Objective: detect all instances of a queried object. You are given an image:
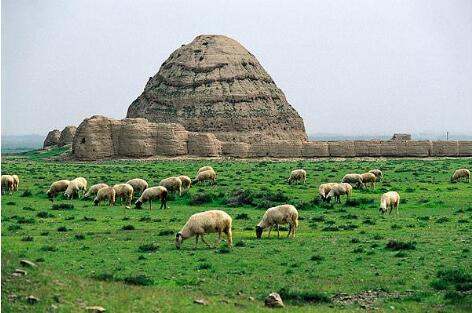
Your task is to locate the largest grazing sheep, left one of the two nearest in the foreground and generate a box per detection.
[175,210,233,249]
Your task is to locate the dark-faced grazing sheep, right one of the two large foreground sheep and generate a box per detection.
[256,204,298,239]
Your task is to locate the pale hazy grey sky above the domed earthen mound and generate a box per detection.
[1,0,472,135]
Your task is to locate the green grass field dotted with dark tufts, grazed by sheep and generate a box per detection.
[1,151,472,312]
